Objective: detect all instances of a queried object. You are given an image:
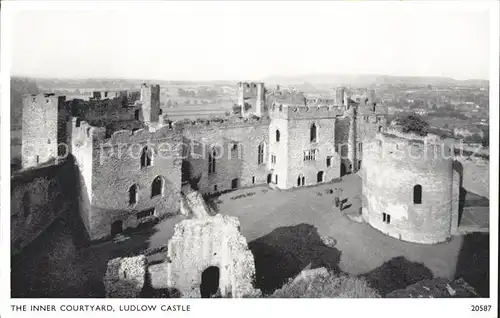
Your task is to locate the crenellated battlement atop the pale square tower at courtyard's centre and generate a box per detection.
[269,102,346,119]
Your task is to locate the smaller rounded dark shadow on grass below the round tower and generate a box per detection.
[361,256,433,297]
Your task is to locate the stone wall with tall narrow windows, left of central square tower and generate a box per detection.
[184,119,269,193]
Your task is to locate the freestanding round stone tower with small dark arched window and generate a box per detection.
[361,133,458,243]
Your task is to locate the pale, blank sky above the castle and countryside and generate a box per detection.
[6,1,492,80]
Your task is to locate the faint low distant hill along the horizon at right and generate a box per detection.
[265,74,489,86]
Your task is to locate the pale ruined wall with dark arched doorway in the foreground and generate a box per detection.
[166,214,255,298]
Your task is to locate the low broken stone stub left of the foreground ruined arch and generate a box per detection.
[103,255,147,298]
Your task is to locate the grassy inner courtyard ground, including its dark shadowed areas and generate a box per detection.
[12,175,489,297]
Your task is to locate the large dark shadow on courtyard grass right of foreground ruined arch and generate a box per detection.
[248,223,340,294]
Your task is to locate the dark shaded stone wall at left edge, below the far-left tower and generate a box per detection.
[10,162,73,254]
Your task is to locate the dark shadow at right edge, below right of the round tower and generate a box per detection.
[455,233,490,297]
